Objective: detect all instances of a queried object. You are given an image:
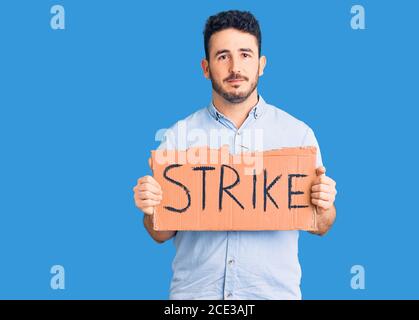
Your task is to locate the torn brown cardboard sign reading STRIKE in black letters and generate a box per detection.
[151,146,317,231]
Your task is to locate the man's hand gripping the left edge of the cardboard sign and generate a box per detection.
[133,176,163,215]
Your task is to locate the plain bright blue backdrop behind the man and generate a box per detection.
[0,0,419,299]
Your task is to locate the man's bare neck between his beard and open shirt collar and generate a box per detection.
[212,89,258,128]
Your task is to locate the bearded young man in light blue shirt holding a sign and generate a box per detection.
[134,11,336,299]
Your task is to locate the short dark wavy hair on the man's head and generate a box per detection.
[204,10,262,61]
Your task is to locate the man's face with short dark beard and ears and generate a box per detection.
[202,29,265,103]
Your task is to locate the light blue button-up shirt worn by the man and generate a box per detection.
[159,96,322,299]
